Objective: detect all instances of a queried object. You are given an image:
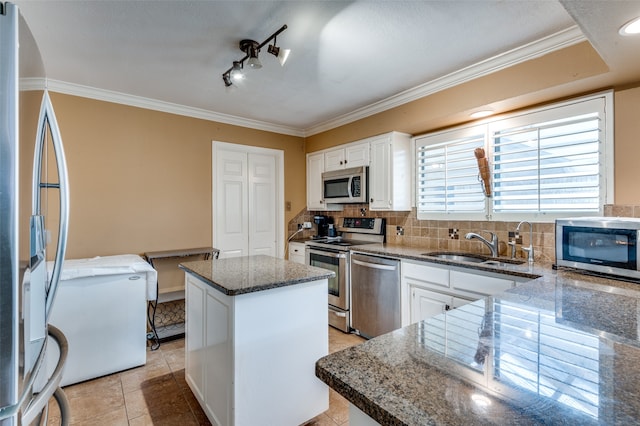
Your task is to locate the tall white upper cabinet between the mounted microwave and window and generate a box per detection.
[368,132,411,211]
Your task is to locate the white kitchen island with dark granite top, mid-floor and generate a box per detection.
[180,256,334,426]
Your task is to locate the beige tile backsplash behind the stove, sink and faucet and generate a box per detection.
[288,204,640,262]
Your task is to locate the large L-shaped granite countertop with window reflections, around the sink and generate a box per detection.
[316,245,640,425]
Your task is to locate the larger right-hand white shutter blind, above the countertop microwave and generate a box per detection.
[490,99,604,214]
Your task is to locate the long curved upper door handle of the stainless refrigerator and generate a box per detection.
[32,90,69,321]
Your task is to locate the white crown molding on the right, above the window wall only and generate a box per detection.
[304,25,587,136]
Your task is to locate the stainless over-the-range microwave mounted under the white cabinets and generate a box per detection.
[322,167,369,204]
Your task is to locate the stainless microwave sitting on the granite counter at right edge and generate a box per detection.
[556,217,640,279]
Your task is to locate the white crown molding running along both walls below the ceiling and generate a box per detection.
[20,26,586,137]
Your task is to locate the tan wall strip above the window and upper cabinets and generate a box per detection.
[306,42,609,152]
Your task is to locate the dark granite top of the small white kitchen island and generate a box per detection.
[179,255,335,296]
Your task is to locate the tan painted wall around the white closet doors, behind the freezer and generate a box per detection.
[21,93,306,258]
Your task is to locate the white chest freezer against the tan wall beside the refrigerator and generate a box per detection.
[47,255,157,386]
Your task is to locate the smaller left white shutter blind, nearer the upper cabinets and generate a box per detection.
[416,127,486,217]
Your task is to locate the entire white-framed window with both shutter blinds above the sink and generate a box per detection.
[415,92,613,221]
